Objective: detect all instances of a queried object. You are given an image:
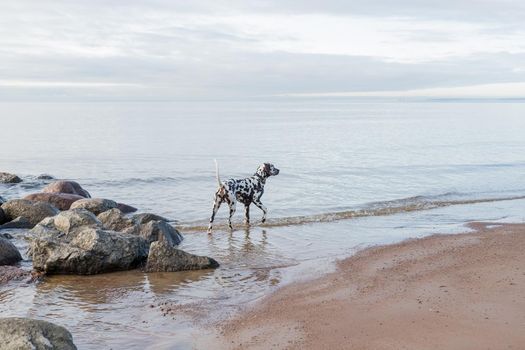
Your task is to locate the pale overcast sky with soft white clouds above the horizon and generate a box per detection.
[0,0,525,100]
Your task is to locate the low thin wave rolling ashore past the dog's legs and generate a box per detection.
[180,192,525,231]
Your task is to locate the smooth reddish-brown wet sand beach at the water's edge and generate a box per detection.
[214,223,525,350]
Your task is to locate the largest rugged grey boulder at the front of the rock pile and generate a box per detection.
[30,227,148,275]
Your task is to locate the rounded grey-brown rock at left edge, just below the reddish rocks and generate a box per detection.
[2,199,59,227]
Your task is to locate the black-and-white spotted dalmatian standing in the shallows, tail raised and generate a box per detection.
[208,161,279,233]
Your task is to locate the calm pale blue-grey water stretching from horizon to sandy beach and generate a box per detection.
[0,100,525,349]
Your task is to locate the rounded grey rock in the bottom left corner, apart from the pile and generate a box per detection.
[0,317,77,350]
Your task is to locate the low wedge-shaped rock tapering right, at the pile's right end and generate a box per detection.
[146,242,219,272]
